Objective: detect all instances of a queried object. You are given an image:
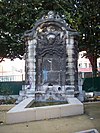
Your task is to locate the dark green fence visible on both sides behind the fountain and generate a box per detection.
[0,77,100,95]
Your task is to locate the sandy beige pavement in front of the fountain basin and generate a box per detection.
[0,102,100,133]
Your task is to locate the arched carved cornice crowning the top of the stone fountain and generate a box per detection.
[24,11,79,39]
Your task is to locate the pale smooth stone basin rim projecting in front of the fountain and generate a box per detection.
[6,98,84,124]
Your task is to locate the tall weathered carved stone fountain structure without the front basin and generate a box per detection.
[21,11,78,101]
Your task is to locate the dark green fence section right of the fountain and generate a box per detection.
[83,77,100,92]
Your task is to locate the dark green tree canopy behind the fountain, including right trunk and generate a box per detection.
[0,0,100,76]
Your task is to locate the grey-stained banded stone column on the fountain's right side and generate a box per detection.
[66,35,76,95]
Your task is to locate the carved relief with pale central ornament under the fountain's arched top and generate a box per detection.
[37,22,65,48]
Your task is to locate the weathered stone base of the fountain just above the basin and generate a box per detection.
[17,84,80,103]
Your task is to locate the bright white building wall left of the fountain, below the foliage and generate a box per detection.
[0,59,25,82]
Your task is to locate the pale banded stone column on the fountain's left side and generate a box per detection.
[26,39,37,92]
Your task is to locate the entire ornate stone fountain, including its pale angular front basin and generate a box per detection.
[6,11,84,124]
